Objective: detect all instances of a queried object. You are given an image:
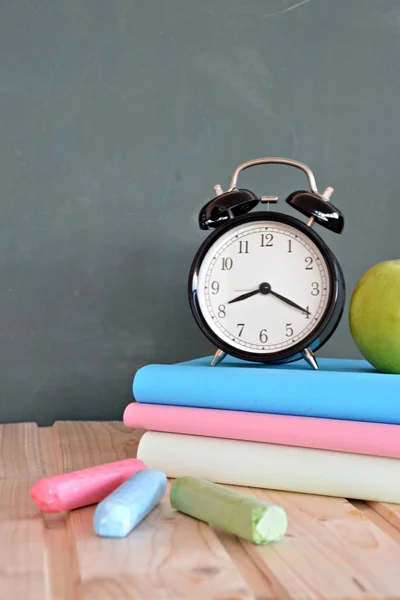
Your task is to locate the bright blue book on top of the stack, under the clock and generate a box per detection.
[133,356,400,424]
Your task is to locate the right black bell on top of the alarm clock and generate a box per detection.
[286,189,344,233]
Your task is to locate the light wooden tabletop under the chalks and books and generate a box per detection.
[0,422,400,600]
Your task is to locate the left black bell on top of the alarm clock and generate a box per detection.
[199,186,260,229]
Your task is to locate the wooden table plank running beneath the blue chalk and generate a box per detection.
[54,422,253,600]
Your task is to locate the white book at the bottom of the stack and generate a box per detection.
[137,431,400,504]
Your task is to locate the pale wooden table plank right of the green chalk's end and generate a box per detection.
[231,488,400,600]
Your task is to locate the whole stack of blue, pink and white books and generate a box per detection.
[123,356,400,503]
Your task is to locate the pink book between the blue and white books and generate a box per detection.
[123,402,400,458]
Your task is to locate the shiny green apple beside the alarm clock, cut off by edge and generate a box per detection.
[349,259,400,374]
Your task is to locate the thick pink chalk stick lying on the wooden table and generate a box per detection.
[29,458,147,513]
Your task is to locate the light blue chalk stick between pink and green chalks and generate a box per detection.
[93,469,167,538]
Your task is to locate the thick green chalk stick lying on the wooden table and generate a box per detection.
[170,476,288,544]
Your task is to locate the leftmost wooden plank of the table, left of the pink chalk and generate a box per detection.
[0,423,49,600]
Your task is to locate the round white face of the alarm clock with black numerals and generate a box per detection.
[195,220,330,354]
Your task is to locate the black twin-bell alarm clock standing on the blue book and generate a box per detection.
[189,157,346,369]
